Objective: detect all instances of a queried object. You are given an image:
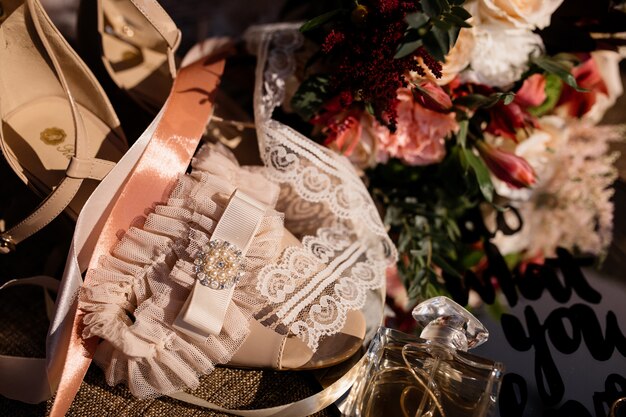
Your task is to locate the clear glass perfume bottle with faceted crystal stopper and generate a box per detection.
[344,297,504,417]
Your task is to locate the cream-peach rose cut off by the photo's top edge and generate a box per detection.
[477,0,563,30]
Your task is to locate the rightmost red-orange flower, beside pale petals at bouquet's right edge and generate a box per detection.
[558,58,609,118]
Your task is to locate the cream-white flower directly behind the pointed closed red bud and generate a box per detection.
[490,116,569,201]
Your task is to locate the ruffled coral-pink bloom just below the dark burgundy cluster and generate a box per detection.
[377,88,459,165]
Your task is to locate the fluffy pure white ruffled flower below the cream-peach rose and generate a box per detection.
[461,25,543,87]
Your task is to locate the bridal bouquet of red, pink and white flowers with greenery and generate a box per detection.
[285,0,626,306]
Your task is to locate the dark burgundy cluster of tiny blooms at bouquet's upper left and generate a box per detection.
[322,0,441,132]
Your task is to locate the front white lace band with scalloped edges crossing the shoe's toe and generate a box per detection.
[257,221,388,350]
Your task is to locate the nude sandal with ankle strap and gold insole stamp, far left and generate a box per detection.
[0,0,128,253]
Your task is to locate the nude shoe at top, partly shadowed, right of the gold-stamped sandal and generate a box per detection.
[95,0,181,114]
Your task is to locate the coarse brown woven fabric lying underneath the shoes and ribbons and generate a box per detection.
[0,268,339,417]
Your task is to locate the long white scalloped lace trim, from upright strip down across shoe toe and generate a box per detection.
[246,24,396,350]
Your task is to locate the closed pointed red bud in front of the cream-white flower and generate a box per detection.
[476,141,536,188]
